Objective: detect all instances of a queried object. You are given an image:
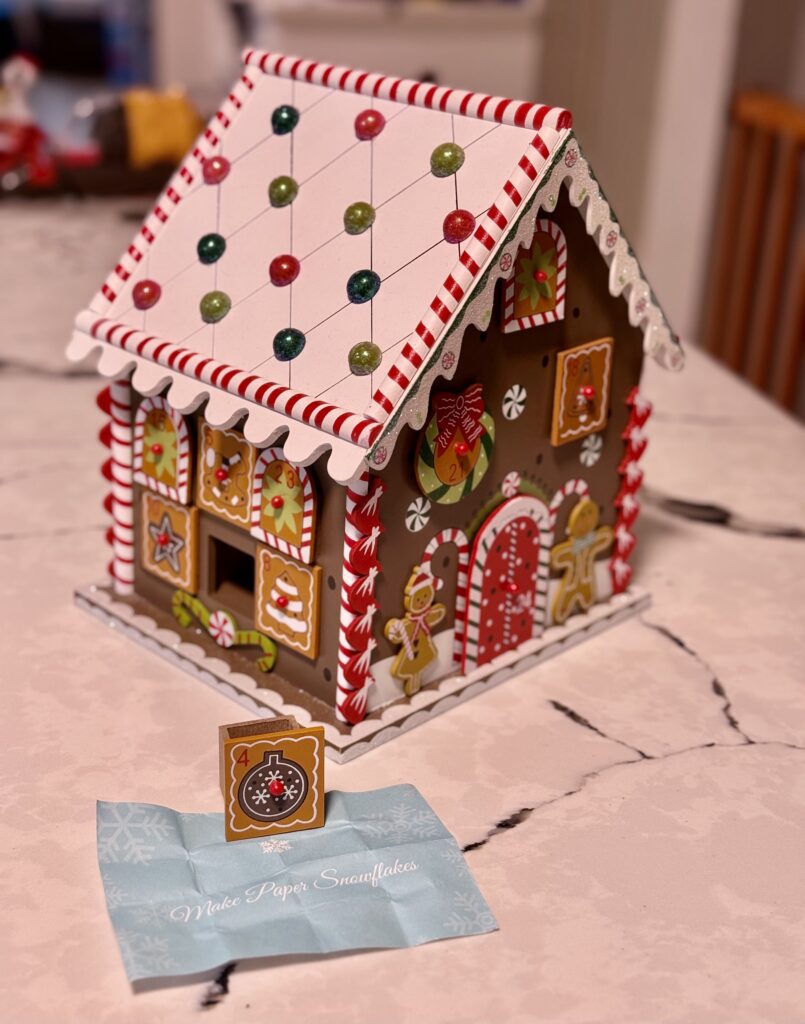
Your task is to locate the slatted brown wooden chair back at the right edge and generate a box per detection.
[702,91,805,409]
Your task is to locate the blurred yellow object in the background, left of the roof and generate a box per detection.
[123,89,202,170]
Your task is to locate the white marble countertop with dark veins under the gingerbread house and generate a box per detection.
[0,201,805,1024]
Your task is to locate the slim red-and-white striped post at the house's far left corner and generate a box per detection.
[109,379,134,595]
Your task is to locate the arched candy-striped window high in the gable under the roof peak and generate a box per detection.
[503,217,567,334]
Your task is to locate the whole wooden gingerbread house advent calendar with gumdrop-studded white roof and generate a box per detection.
[70,50,682,760]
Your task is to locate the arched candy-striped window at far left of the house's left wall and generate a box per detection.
[134,397,190,505]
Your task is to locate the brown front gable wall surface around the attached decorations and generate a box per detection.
[376,190,643,658]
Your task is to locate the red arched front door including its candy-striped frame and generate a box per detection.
[462,495,552,673]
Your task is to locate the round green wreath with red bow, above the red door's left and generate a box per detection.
[416,384,495,505]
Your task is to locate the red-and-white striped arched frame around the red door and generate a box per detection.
[462,495,554,673]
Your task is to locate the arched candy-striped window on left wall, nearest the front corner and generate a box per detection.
[251,447,316,564]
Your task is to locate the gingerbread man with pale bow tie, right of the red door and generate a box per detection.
[551,498,612,624]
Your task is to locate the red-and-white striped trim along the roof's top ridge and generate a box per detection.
[243,49,573,130]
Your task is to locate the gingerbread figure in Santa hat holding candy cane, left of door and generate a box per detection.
[383,565,446,696]
